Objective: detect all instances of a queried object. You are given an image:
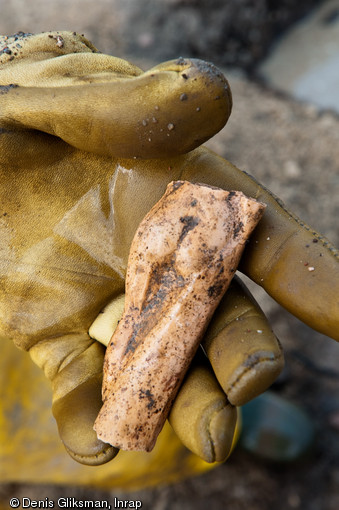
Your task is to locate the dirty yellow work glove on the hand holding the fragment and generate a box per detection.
[0,32,339,465]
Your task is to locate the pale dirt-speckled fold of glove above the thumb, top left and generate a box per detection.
[0,31,142,82]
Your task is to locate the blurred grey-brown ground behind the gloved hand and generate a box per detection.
[0,0,339,510]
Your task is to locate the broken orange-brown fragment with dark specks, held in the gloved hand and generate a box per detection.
[94,181,265,451]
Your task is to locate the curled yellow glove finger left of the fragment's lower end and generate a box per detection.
[30,334,118,465]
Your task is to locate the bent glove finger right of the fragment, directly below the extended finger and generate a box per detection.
[202,277,284,406]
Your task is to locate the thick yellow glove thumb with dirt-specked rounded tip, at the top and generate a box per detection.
[0,32,232,158]
